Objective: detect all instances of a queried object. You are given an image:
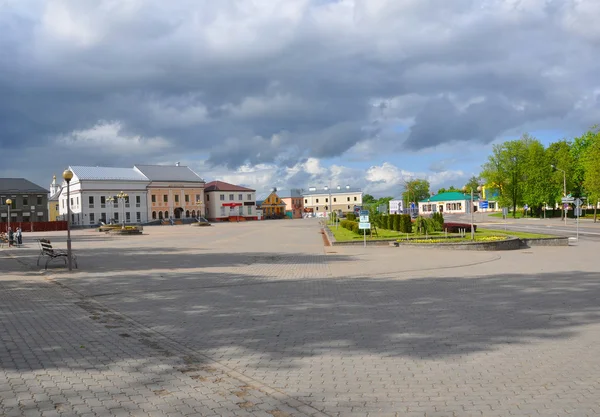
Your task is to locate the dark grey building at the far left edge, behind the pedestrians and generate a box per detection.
[0,178,48,223]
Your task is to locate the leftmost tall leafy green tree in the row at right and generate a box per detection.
[481,135,530,217]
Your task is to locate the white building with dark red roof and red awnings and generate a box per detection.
[204,181,257,221]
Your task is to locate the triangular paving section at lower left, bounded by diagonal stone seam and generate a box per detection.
[0,251,319,417]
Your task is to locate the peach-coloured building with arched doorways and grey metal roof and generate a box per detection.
[134,164,206,220]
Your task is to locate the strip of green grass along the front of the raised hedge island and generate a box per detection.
[329,226,554,242]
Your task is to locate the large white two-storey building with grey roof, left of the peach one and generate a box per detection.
[58,166,150,226]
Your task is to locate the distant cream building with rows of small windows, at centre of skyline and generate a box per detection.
[302,186,363,217]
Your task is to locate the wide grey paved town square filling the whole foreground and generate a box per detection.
[0,220,600,416]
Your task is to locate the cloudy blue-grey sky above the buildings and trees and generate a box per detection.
[0,0,600,196]
